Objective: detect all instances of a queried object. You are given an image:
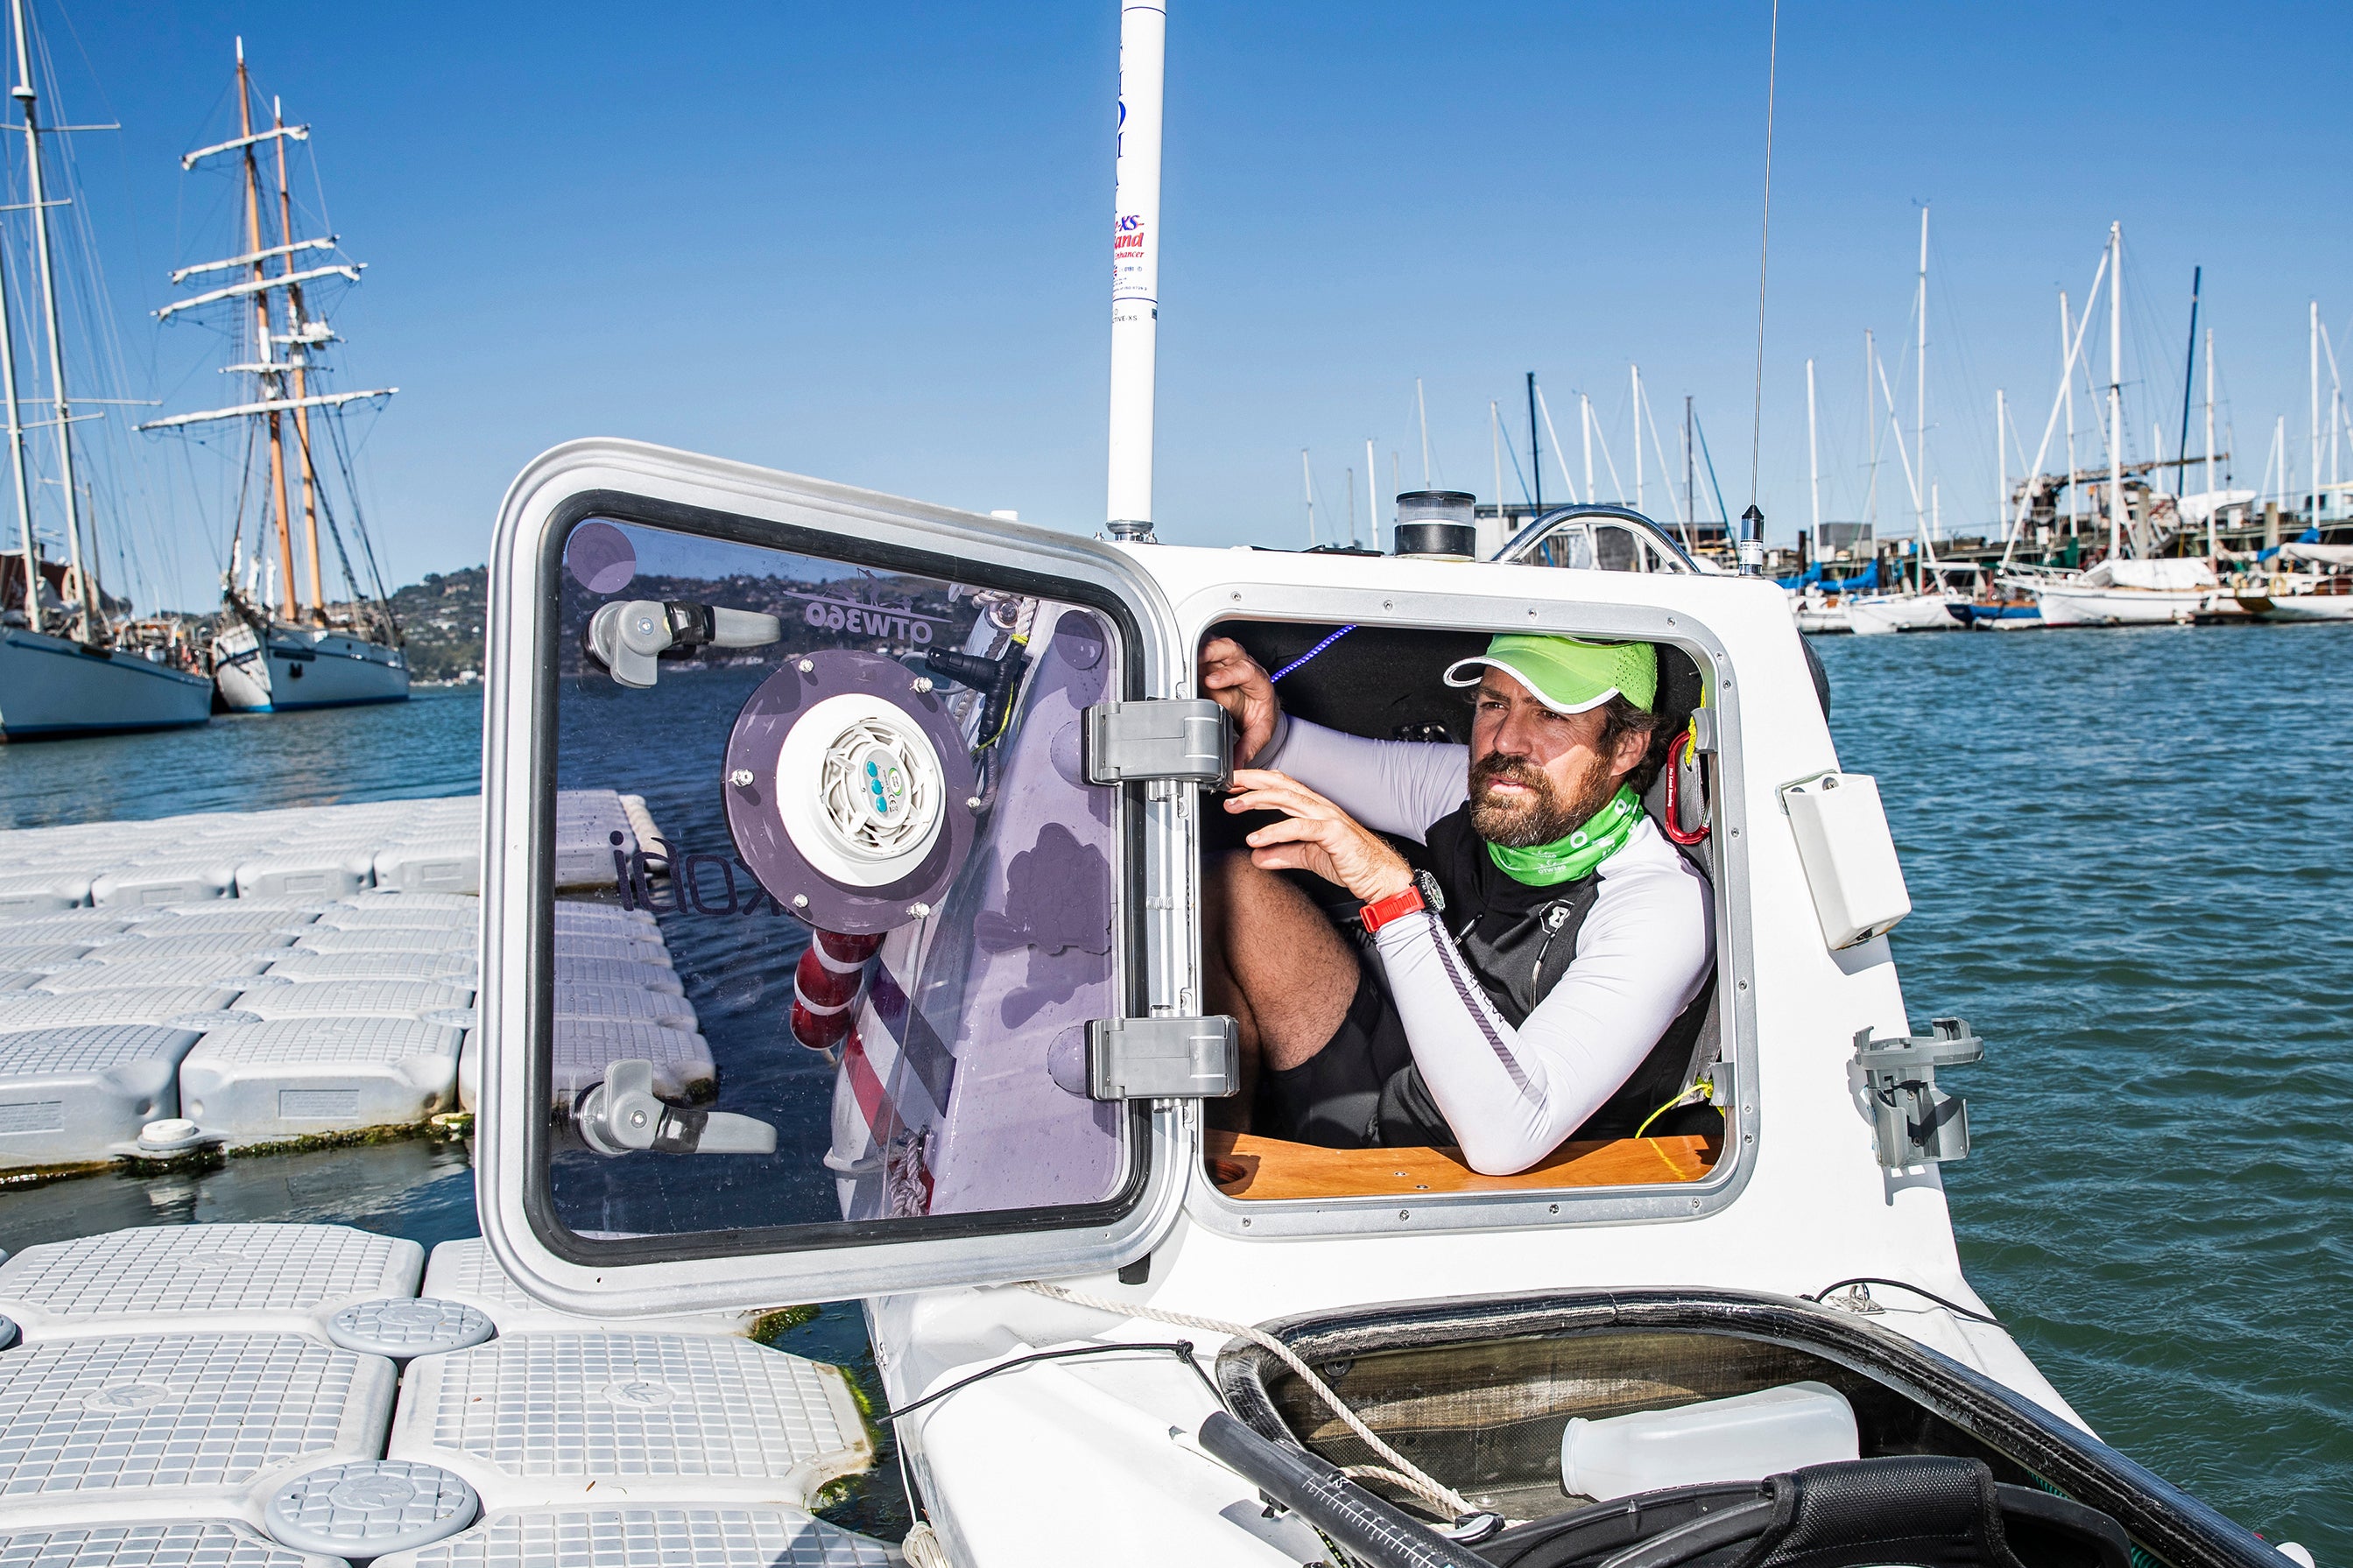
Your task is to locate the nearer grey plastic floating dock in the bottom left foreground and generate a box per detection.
[0,1225,897,1568]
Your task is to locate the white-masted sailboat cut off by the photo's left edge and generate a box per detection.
[0,0,212,741]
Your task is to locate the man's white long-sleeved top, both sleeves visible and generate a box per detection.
[1250,714,1713,1176]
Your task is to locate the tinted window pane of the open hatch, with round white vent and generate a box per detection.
[548,519,1127,1236]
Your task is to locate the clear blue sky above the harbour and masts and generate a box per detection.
[11,0,2353,604]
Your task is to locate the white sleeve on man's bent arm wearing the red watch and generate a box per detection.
[1374,823,1710,1176]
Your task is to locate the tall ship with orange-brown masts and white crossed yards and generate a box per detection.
[139,38,410,713]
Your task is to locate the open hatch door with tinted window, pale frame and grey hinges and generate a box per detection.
[476,442,1233,1314]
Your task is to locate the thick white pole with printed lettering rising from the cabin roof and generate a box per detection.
[1110,0,1167,538]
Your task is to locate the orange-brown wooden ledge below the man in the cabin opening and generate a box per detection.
[1207,1131,1722,1201]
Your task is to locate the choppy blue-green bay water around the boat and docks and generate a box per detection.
[0,628,2353,1565]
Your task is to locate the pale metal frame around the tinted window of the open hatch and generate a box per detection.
[476,439,1195,1314]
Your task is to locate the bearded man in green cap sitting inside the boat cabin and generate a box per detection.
[1200,635,1713,1176]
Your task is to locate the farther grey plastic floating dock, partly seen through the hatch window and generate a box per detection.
[0,790,687,1171]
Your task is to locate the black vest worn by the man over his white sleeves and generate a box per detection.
[1424,802,1715,1138]
